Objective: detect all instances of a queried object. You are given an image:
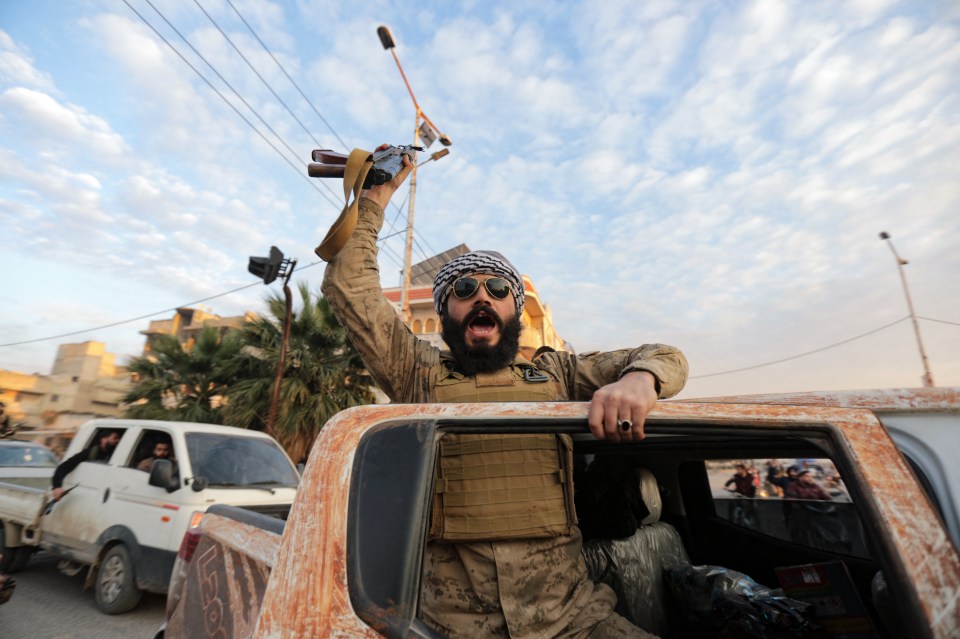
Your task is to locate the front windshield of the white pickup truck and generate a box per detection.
[186,433,298,488]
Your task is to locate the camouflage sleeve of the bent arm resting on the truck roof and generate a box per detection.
[537,344,688,401]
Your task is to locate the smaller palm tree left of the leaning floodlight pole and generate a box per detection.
[123,327,242,424]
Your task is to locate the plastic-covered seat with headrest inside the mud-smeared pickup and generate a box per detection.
[583,468,690,637]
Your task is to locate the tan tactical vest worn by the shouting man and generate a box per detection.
[429,361,577,542]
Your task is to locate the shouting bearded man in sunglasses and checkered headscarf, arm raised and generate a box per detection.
[318,147,687,639]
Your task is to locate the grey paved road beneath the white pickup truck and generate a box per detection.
[0,553,166,639]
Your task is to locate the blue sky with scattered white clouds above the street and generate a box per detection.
[0,0,960,397]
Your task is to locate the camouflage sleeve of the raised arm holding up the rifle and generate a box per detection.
[321,198,439,402]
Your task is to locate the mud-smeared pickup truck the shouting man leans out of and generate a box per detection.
[158,389,960,638]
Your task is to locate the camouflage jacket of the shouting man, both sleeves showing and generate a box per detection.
[322,198,687,403]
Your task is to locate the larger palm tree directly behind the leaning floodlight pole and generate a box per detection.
[223,283,373,460]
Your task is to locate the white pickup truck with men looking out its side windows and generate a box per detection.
[0,419,300,614]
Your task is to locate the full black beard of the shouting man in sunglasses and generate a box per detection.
[440,306,523,376]
